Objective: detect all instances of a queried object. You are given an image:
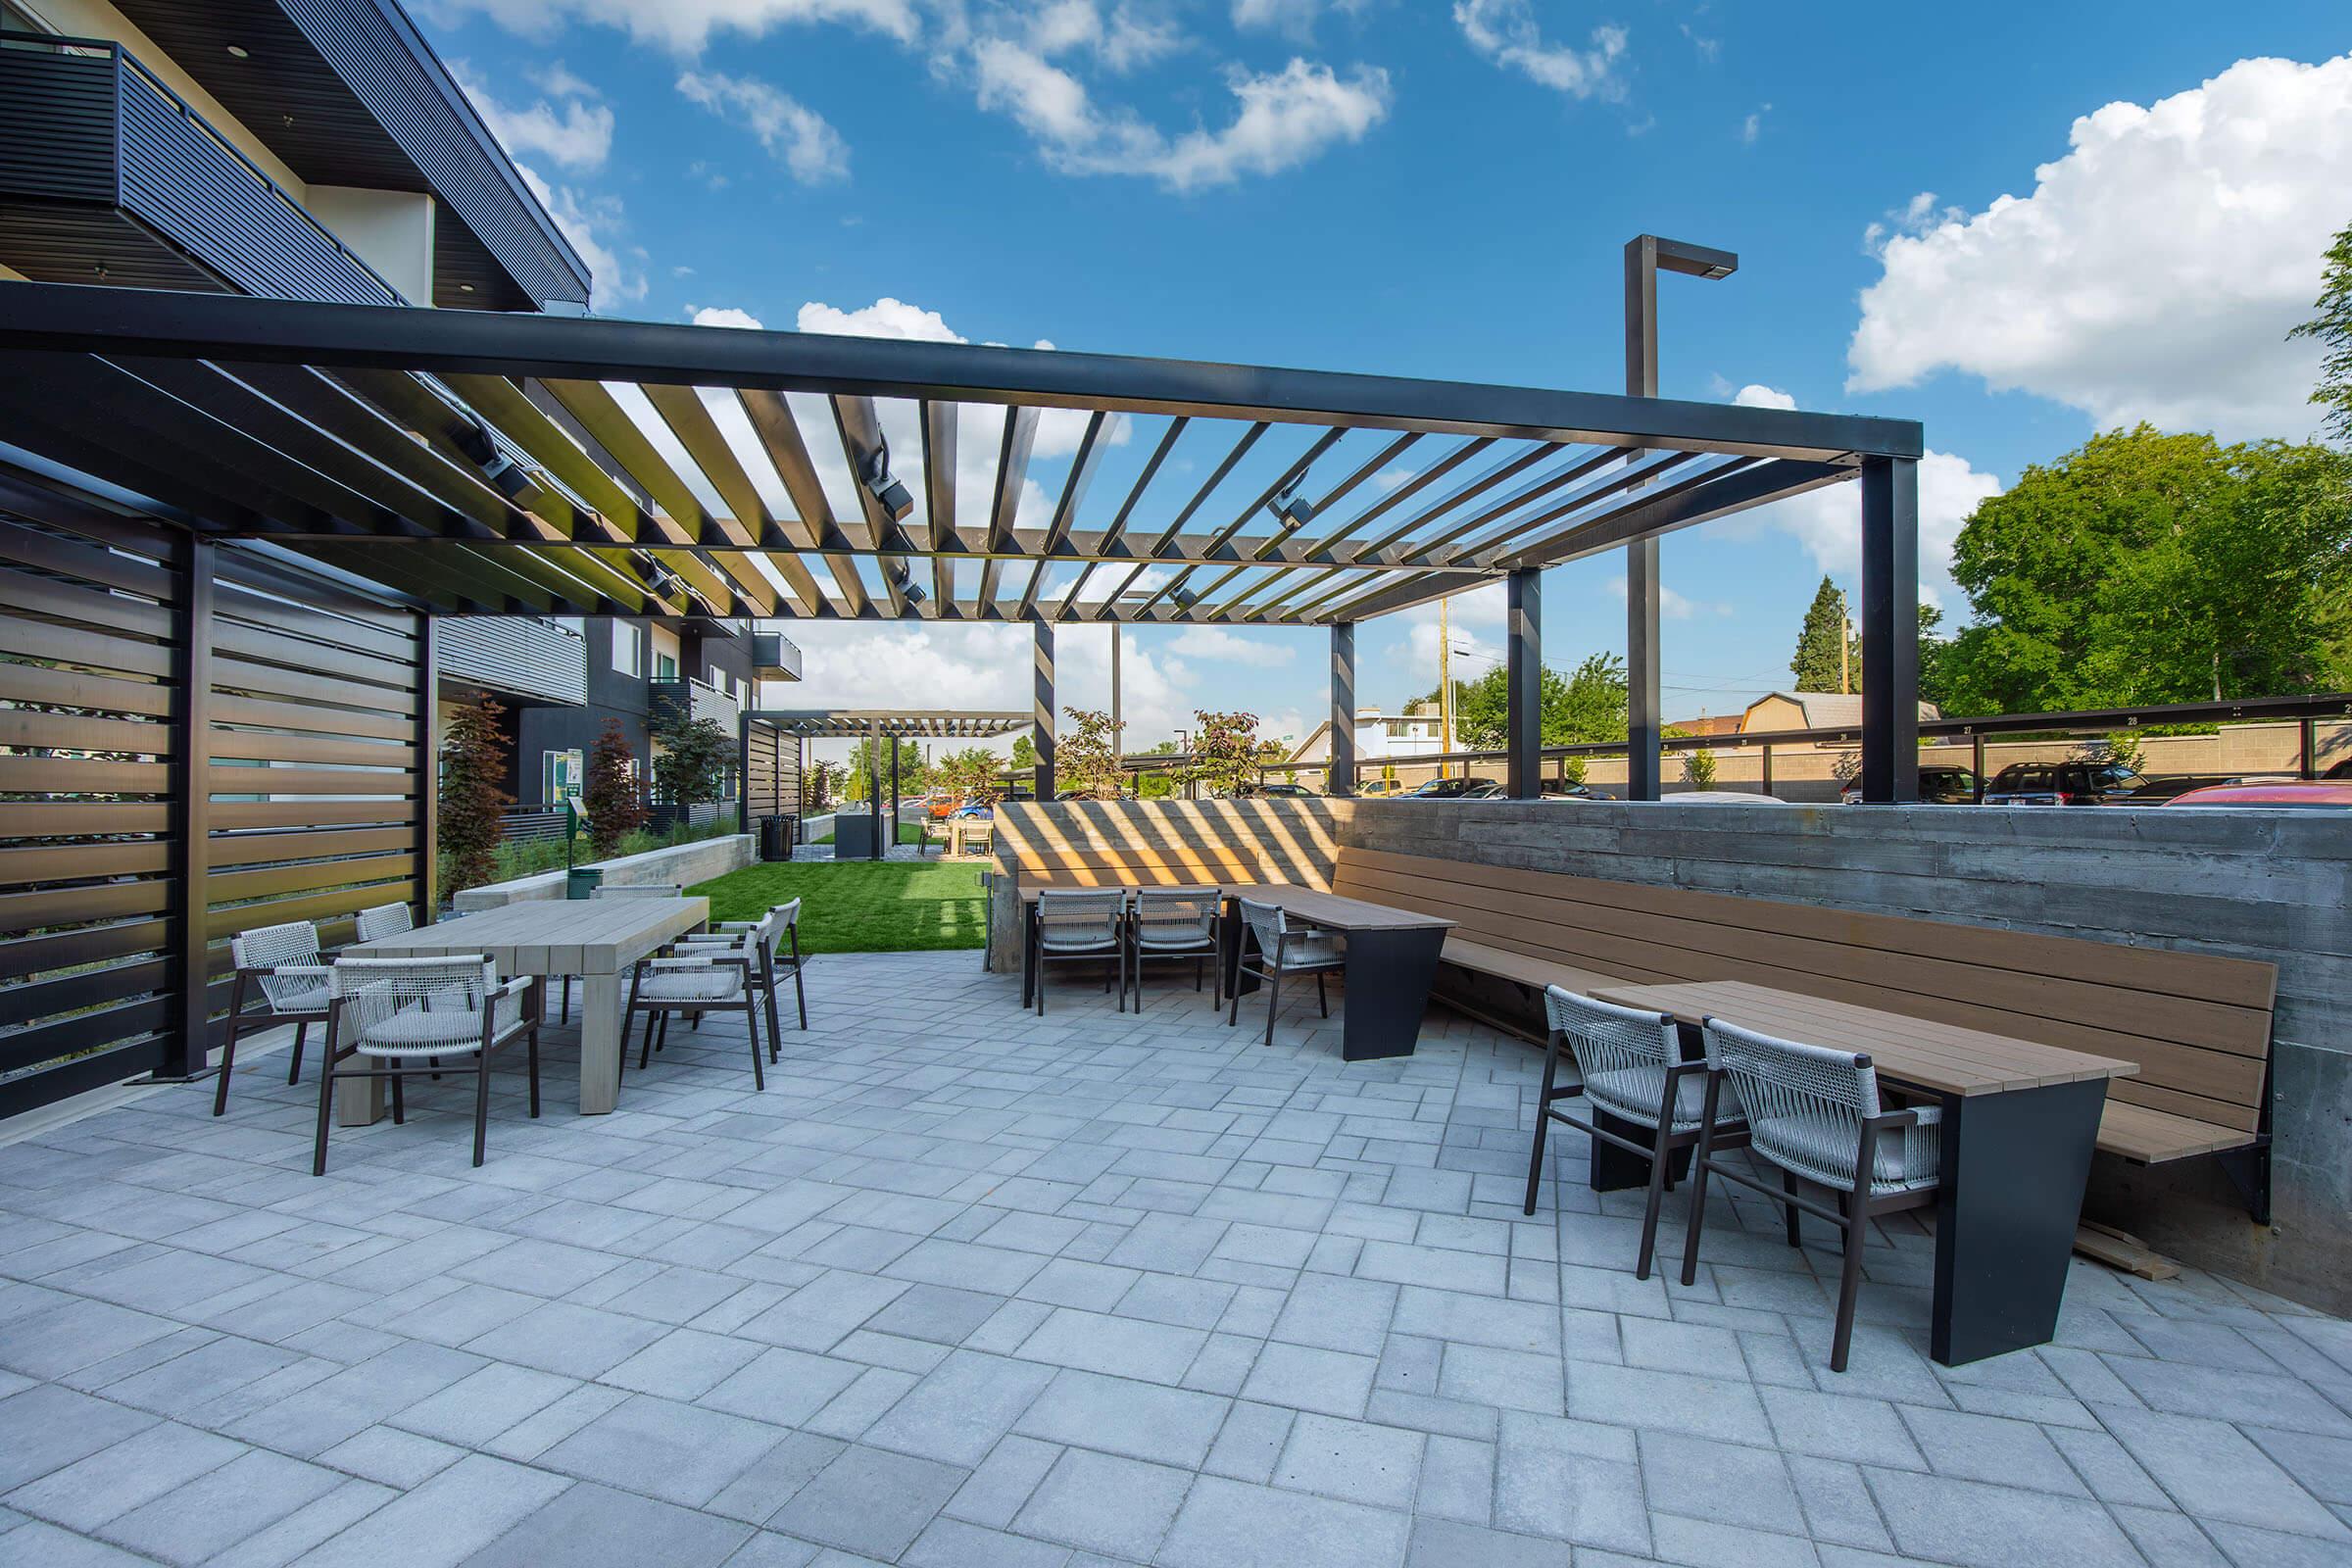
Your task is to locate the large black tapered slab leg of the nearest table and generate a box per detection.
[1929,1079,2107,1366]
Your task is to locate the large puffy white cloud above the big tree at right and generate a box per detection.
[1846,54,2352,437]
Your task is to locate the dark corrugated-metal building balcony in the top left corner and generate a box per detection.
[0,35,407,306]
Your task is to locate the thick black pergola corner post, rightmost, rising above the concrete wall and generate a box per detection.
[1863,459,1919,804]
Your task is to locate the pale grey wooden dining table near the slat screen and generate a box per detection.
[336,898,710,1126]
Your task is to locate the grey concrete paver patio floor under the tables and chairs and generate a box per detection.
[0,953,2352,1568]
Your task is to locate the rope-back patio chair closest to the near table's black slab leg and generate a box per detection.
[1682,1018,1942,1373]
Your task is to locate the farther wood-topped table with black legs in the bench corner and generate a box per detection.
[1021,882,1453,1062]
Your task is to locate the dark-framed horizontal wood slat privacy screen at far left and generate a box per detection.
[0,491,433,1114]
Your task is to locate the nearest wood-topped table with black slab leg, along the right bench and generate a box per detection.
[1592,980,2138,1366]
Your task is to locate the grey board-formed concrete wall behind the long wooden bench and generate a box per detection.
[998,800,2352,1312]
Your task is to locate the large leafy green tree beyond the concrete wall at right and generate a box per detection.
[1938,425,2352,712]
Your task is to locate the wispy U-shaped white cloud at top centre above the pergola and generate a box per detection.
[971,37,1390,190]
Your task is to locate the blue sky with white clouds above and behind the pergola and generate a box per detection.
[416,0,2352,743]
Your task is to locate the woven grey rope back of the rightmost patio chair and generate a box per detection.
[1705,1018,1905,1185]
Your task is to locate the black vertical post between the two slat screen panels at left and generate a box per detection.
[155,536,216,1079]
